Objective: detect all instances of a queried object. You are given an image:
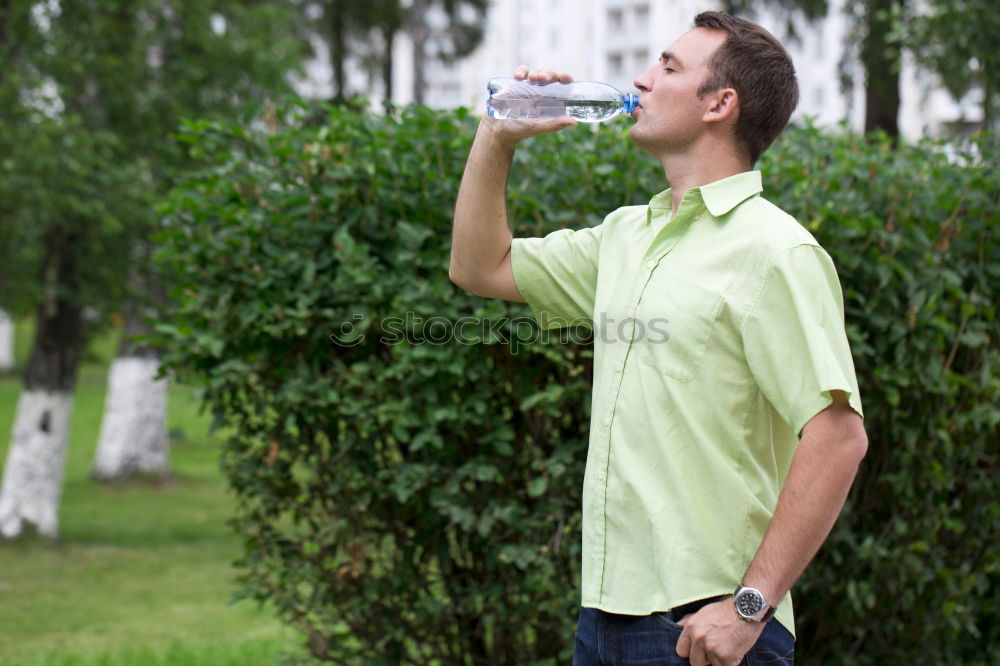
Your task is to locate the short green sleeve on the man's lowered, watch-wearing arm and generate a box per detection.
[743,244,863,435]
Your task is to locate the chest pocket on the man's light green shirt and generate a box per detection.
[637,271,725,382]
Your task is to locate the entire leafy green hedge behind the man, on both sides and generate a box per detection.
[152,104,1000,664]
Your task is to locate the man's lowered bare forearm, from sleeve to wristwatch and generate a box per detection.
[743,396,867,604]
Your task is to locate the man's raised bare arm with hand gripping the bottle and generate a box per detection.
[448,65,576,302]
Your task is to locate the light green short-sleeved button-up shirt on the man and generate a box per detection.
[511,171,861,632]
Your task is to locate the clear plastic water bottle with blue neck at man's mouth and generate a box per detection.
[486,77,639,123]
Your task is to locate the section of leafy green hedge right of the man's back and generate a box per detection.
[764,126,1000,665]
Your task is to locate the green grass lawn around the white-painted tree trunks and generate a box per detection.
[0,323,300,666]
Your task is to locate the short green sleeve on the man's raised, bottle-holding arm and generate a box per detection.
[510,225,604,330]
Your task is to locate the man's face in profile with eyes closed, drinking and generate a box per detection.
[629,28,727,157]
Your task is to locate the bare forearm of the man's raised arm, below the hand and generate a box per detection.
[448,120,514,286]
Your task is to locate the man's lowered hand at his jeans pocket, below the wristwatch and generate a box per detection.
[677,599,764,666]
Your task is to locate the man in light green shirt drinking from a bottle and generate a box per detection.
[449,12,867,666]
